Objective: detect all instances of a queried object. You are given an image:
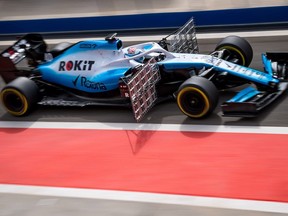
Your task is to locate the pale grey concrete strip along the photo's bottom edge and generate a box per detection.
[0,194,287,216]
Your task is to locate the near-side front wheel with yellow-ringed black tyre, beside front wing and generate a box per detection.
[177,76,219,119]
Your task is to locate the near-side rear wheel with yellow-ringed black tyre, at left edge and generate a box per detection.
[0,77,39,116]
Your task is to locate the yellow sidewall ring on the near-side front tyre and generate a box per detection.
[177,86,210,118]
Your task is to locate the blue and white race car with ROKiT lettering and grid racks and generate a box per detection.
[0,19,288,121]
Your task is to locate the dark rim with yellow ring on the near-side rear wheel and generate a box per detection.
[1,88,28,116]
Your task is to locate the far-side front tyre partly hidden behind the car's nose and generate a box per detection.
[215,35,253,67]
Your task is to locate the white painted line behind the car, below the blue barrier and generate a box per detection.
[0,30,288,46]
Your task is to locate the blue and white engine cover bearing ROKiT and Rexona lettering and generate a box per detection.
[37,40,130,93]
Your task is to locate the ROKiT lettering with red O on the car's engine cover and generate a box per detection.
[58,60,95,71]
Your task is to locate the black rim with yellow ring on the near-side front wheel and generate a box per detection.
[177,87,210,118]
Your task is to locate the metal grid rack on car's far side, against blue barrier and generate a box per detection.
[158,18,199,54]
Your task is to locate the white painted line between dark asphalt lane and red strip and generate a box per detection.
[0,121,288,134]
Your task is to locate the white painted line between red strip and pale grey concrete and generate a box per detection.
[0,184,288,214]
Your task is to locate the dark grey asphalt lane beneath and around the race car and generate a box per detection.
[0,35,288,127]
